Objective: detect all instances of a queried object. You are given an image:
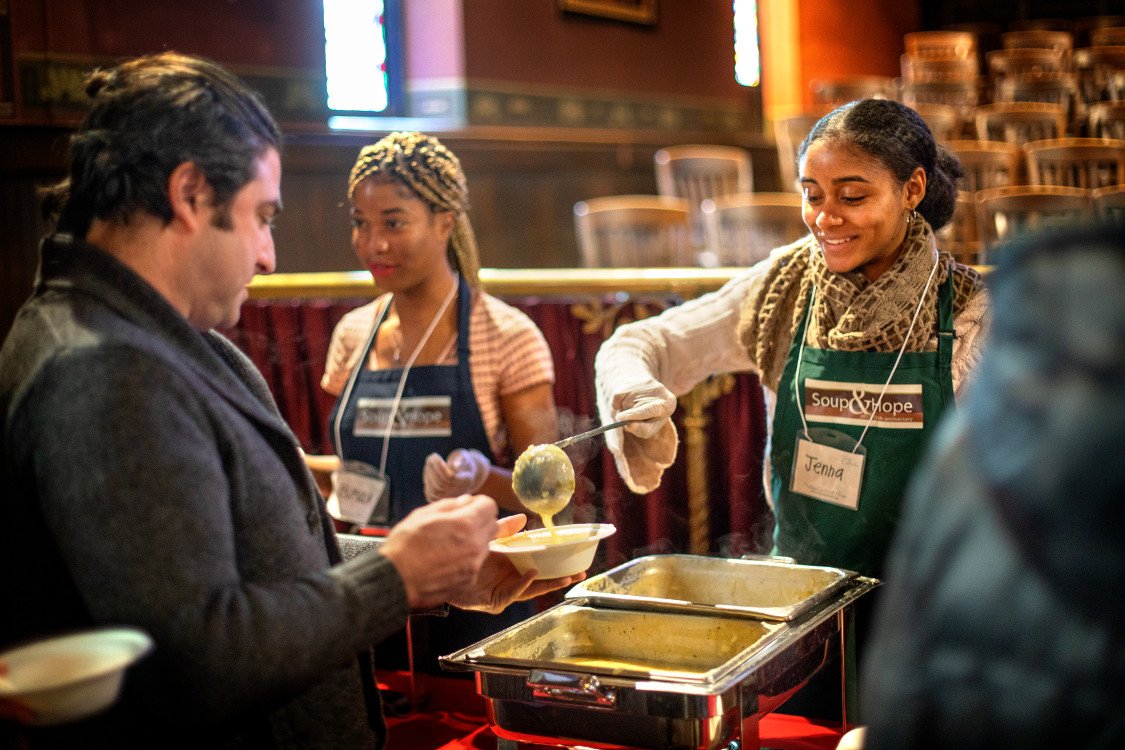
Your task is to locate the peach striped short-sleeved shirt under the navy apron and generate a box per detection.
[321,292,555,461]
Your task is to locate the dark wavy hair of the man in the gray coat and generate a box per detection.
[43,52,281,237]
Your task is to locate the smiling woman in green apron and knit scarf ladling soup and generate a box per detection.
[596,99,988,717]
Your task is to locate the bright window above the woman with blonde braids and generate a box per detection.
[324,0,403,116]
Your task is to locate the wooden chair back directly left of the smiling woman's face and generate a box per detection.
[702,192,809,265]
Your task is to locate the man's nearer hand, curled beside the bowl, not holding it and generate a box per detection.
[380,495,500,609]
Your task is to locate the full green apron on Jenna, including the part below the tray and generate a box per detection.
[770,277,954,722]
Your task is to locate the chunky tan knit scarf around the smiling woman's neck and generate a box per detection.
[738,213,984,391]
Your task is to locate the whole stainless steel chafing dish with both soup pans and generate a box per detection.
[441,555,879,750]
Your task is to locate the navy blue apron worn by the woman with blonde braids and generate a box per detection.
[329,279,533,674]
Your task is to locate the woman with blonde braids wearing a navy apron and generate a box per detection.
[312,133,557,666]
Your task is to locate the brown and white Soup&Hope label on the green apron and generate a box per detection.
[804,378,926,430]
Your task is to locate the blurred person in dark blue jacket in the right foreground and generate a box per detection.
[863,224,1125,750]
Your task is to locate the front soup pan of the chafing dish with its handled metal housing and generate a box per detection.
[440,561,879,750]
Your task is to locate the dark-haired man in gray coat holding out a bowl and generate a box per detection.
[0,53,577,748]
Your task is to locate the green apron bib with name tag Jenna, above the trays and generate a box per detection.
[770,275,953,578]
